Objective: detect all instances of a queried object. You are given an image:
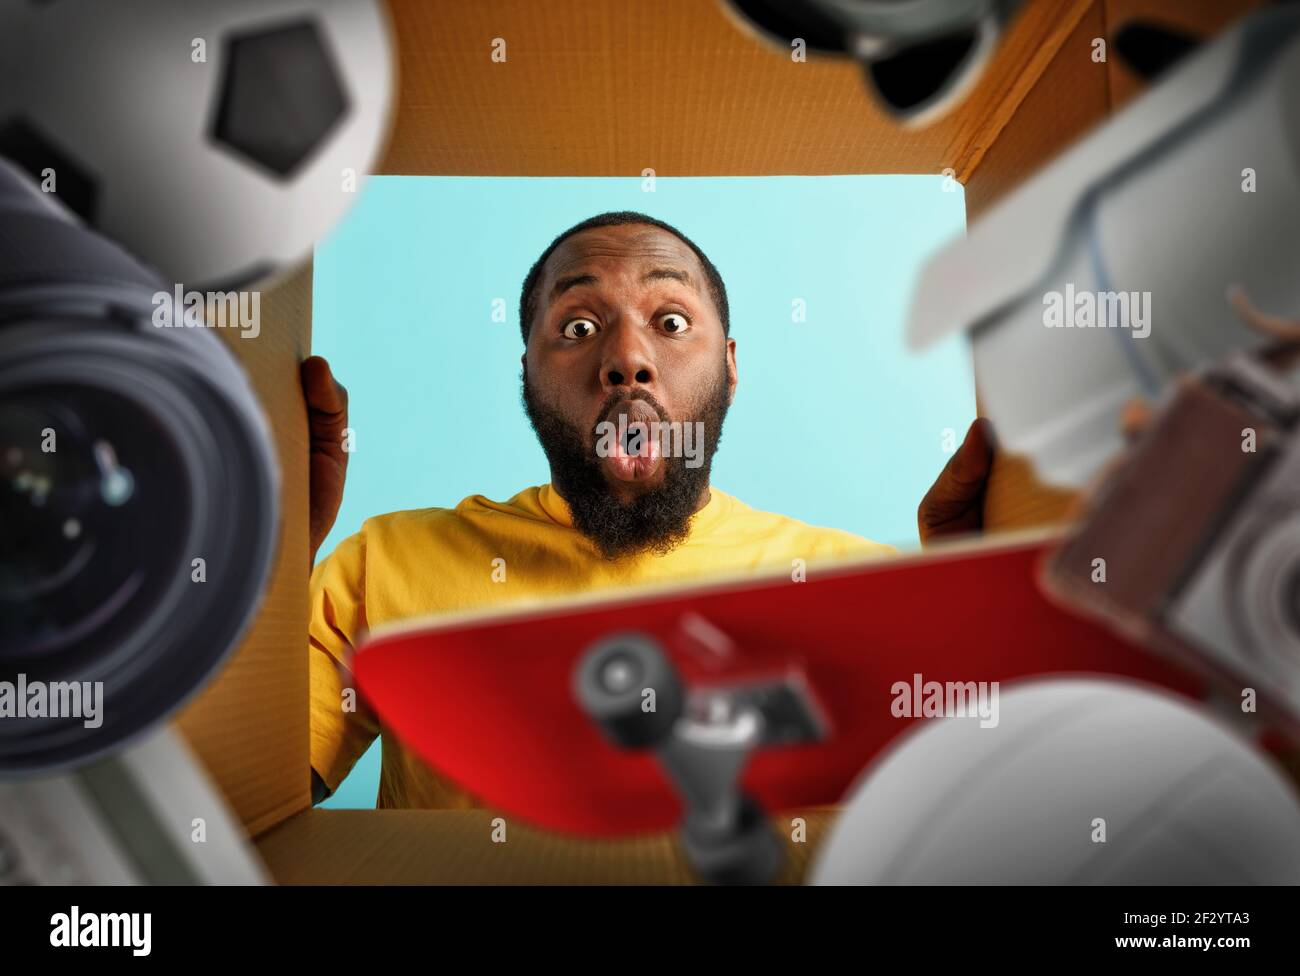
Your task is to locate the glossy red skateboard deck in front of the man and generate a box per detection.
[355,530,1204,836]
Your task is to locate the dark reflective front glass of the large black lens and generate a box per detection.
[0,386,190,671]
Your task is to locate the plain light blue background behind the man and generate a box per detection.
[312,175,975,807]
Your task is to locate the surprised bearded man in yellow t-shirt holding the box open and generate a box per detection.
[303,212,991,808]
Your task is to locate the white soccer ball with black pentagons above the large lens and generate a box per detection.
[0,0,394,290]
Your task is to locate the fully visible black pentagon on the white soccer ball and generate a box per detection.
[212,21,348,179]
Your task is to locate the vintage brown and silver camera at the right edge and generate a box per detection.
[1043,353,1300,733]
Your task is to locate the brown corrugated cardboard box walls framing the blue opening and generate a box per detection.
[170,0,1256,882]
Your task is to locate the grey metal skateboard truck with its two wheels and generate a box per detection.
[575,632,822,884]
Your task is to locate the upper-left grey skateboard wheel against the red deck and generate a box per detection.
[575,633,684,749]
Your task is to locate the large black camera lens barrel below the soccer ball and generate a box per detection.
[0,160,280,775]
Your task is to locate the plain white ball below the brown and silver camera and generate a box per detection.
[813,678,1300,885]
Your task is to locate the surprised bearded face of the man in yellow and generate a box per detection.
[523,224,736,556]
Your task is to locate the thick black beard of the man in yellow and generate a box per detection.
[524,363,728,560]
